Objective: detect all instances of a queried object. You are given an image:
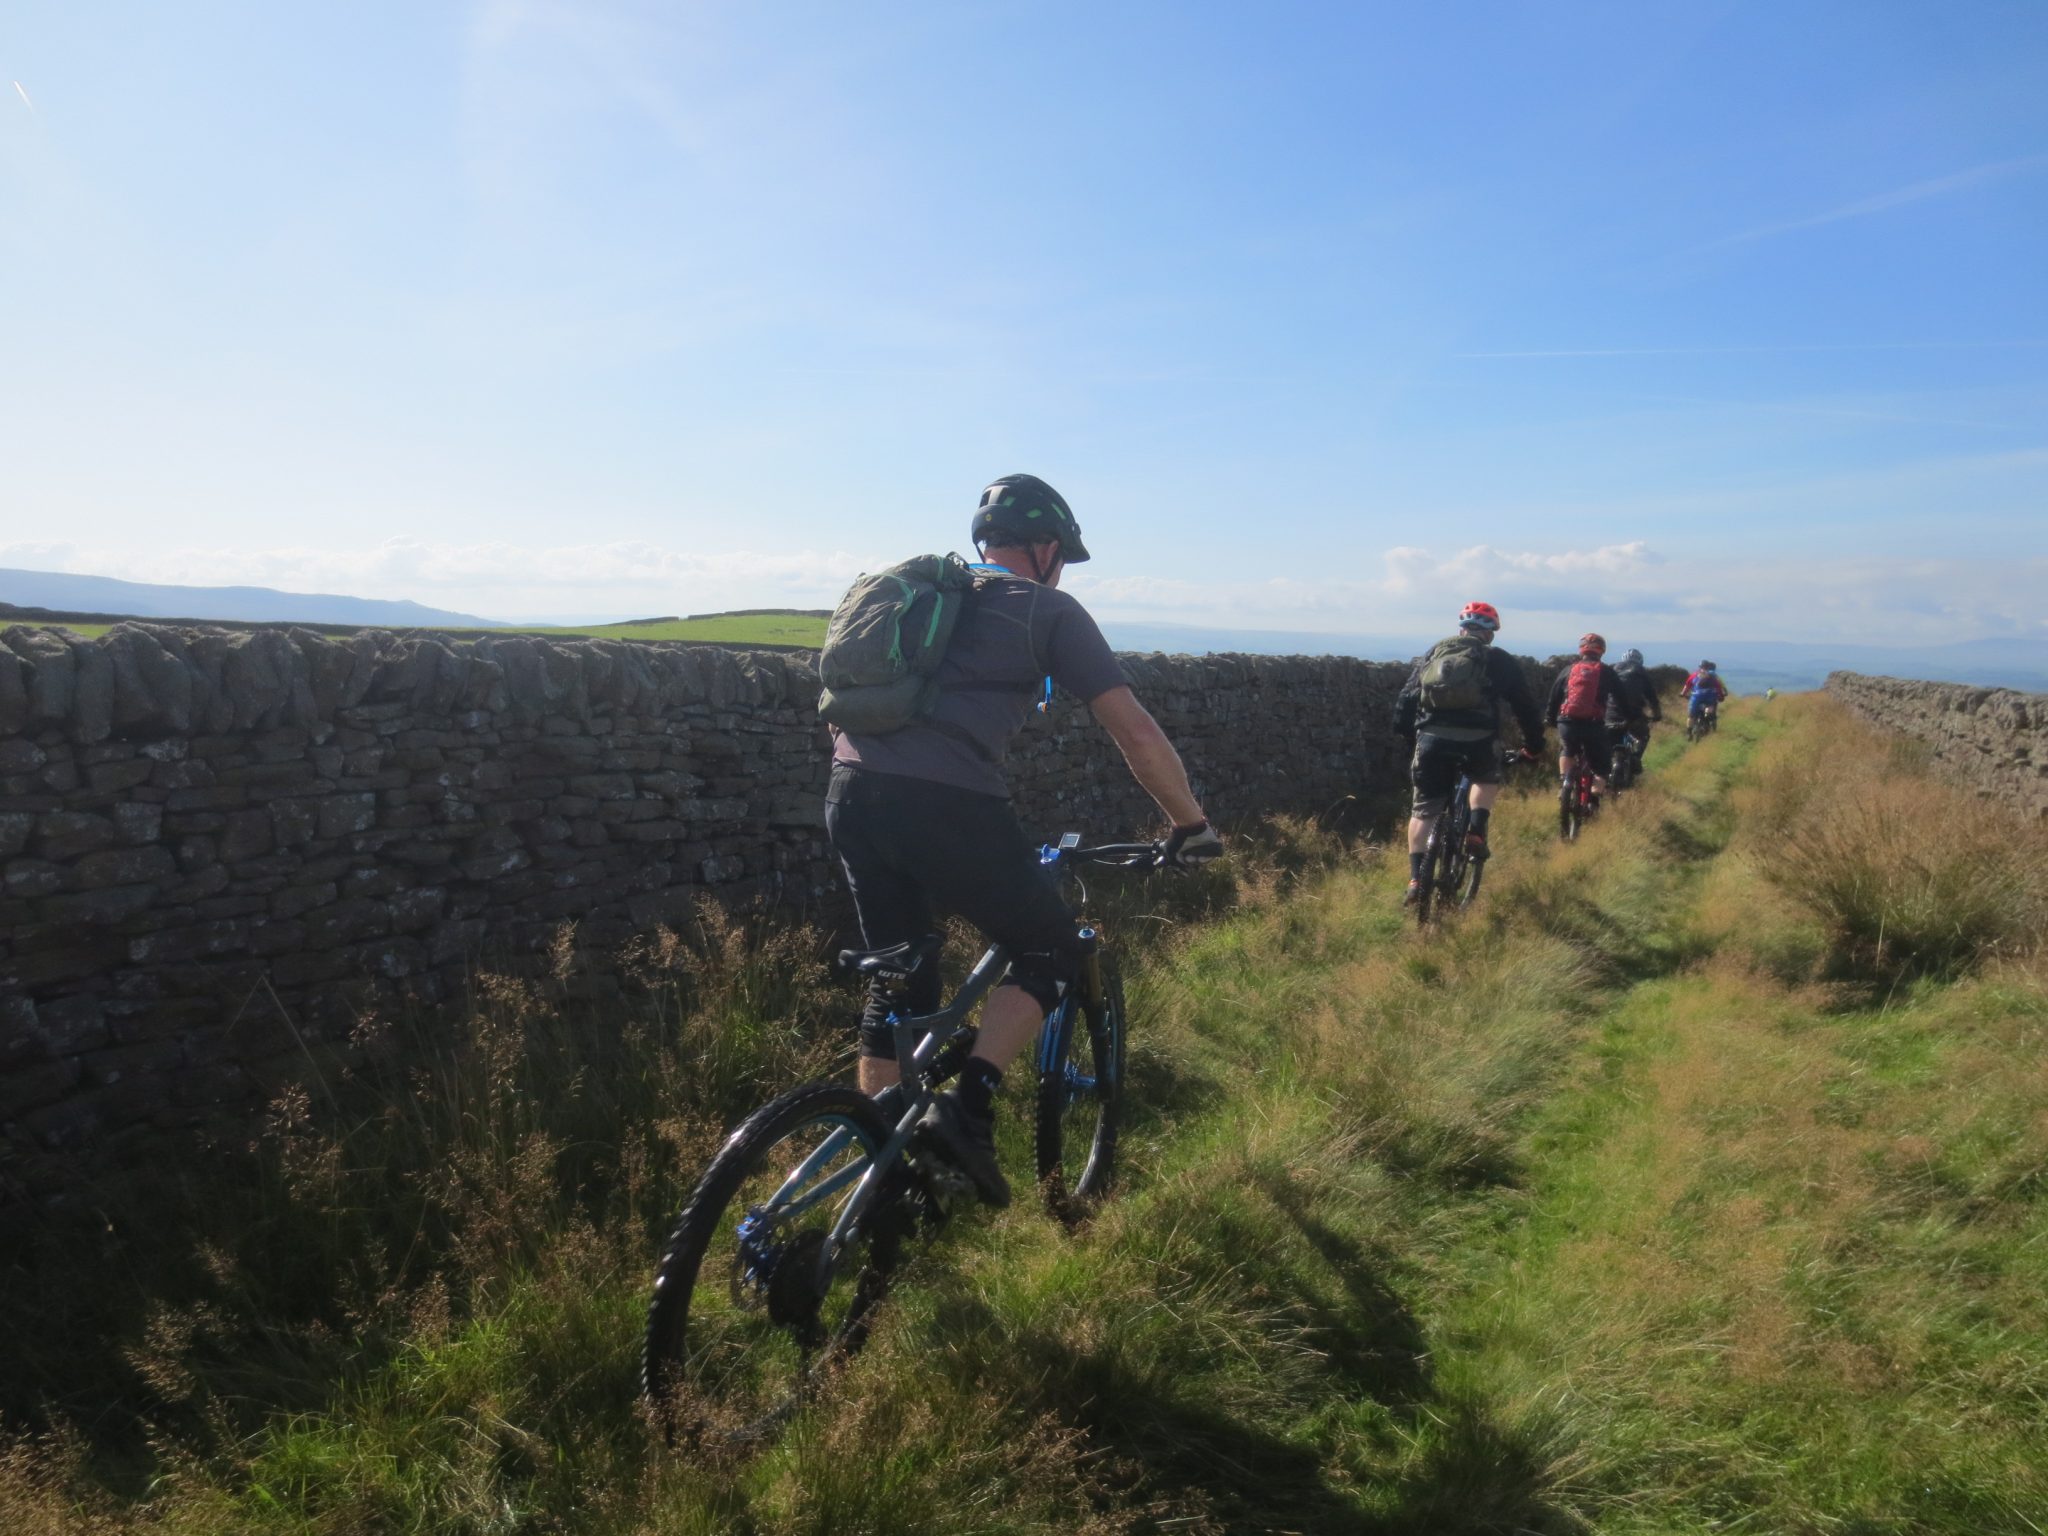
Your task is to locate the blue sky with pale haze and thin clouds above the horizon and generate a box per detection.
[0,0,2048,641]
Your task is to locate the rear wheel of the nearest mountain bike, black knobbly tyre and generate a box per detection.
[641,1083,911,1444]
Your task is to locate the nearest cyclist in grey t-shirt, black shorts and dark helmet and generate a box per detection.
[825,475,1223,1206]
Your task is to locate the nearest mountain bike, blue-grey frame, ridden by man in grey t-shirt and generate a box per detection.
[641,831,1165,1444]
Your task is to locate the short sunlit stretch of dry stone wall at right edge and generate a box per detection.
[1827,672,2048,817]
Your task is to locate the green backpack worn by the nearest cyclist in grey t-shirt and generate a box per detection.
[817,555,975,735]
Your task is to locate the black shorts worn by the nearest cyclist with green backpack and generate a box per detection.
[825,764,1081,1057]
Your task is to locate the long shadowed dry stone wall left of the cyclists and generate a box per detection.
[0,625,1534,1196]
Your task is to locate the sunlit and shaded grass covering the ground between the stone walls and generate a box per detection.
[0,700,2048,1536]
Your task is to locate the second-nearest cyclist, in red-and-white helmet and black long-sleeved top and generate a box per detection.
[1395,602,1542,905]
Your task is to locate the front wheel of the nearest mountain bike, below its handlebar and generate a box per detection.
[1036,952,1124,1225]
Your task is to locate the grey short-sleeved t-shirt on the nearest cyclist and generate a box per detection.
[831,567,1124,799]
